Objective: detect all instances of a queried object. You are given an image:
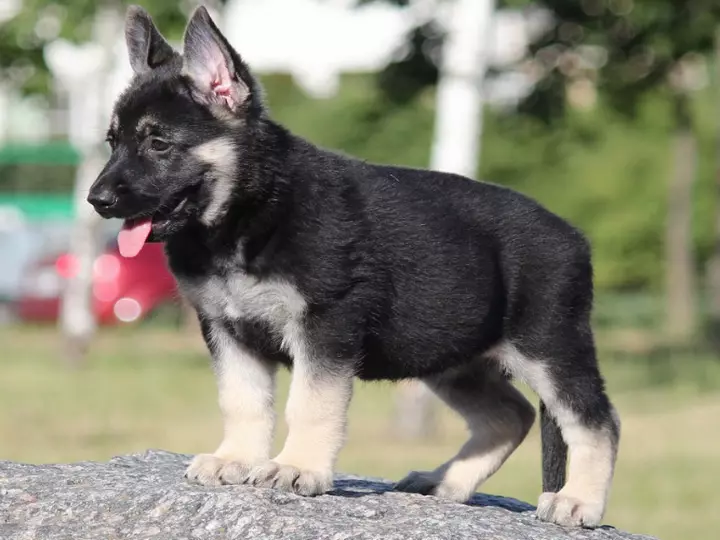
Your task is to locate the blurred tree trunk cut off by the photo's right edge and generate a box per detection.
[707,26,720,353]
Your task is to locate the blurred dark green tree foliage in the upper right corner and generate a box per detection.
[514,0,720,121]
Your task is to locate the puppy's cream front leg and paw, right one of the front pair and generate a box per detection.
[250,355,353,496]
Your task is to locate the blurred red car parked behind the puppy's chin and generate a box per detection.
[14,241,178,325]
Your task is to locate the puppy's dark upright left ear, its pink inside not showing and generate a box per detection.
[125,6,176,74]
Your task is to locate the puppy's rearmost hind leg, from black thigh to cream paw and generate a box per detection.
[488,230,620,527]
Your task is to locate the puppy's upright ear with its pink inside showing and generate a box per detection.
[183,6,252,112]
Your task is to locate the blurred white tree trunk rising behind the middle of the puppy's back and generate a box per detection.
[394,0,495,439]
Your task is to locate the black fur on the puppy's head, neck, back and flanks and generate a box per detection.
[90,5,612,510]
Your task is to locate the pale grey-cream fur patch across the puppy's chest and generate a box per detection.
[178,272,306,334]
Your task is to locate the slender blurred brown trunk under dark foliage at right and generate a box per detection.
[666,92,697,342]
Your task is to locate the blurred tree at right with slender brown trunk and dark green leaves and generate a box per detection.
[524,0,720,340]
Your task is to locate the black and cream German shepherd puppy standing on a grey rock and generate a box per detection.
[88,6,620,526]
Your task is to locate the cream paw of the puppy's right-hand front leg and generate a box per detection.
[248,461,333,497]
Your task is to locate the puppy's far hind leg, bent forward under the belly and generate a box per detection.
[395,359,535,502]
